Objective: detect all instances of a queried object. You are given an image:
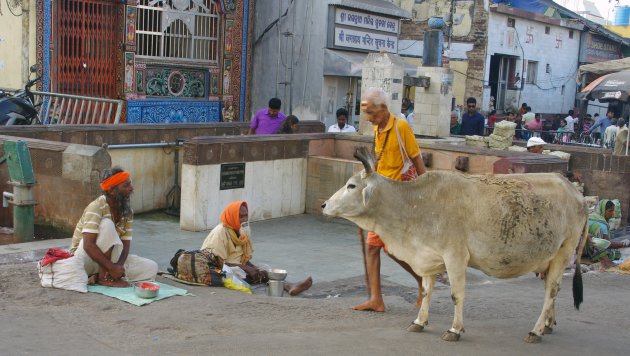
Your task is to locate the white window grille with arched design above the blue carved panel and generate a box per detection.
[136,0,219,64]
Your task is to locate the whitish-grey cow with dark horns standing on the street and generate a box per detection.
[322,148,588,342]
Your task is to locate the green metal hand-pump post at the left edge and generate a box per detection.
[2,140,37,242]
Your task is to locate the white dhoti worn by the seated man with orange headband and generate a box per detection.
[75,219,158,282]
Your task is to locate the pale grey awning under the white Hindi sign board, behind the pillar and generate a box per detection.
[324,48,418,78]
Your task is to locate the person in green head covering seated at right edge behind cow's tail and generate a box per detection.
[584,199,630,268]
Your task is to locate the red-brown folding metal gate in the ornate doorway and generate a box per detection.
[51,0,124,98]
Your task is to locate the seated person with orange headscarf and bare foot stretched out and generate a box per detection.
[201,201,313,295]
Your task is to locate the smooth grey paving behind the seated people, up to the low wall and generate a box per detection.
[0,212,476,288]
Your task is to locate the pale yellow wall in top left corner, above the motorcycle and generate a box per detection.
[0,0,37,89]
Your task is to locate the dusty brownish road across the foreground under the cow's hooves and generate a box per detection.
[0,262,630,355]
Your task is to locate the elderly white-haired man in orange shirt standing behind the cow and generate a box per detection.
[353,88,426,312]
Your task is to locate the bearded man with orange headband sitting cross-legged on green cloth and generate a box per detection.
[70,167,158,287]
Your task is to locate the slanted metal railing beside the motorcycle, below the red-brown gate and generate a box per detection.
[33,91,123,125]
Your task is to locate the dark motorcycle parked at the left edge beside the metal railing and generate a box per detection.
[0,65,41,126]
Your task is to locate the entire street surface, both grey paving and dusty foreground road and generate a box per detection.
[0,213,630,355]
